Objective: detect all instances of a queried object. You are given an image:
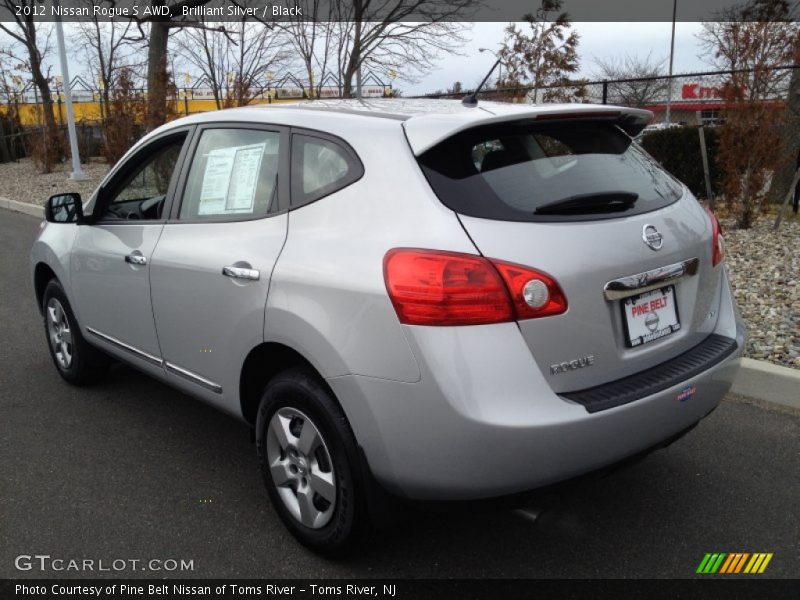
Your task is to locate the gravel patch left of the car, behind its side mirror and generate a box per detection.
[0,158,109,205]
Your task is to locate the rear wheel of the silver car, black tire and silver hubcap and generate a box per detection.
[256,368,368,557]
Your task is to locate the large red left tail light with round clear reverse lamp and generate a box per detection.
[383,248,567,325]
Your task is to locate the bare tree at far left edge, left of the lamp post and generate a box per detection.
[0,0,62,166]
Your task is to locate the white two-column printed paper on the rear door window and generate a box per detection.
[197,142,266,215]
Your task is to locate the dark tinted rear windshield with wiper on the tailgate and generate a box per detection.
[419,121,682,221]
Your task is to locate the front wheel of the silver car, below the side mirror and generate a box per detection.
[42,279,111,385]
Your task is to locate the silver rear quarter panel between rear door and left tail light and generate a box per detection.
[264,115,475,382]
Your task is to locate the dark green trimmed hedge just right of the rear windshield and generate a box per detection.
[641,127,721,198]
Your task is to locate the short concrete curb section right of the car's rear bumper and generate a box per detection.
[731,358,800,409]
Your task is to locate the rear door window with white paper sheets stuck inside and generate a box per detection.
[179,128,280,221]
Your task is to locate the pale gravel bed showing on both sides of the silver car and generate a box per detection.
[0,159,800,369]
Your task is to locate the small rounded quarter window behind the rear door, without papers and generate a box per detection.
[292,134,364,206]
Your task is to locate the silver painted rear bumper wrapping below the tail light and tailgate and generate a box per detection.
[328,270,745,500]
